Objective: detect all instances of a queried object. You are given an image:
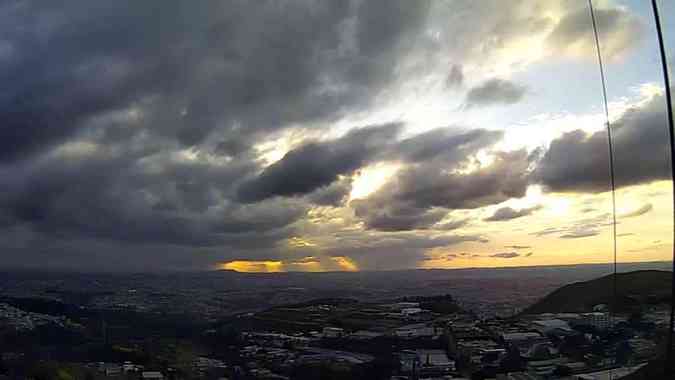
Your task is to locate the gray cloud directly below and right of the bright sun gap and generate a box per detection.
[351,151,529,230]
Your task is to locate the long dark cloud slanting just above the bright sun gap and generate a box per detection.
[238,124,502,206]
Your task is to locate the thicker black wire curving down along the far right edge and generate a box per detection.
[652,0,675,373]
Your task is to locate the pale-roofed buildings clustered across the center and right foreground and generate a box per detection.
[226,302,656,380]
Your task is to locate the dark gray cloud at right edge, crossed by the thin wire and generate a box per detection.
[534,92,670,193]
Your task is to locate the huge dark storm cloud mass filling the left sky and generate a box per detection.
[0,0,440,266]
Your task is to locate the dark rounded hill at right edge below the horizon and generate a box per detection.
[523,270,673,314]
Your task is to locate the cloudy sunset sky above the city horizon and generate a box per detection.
[0,0,675,272]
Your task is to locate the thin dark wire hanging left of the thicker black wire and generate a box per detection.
[588,4,617,378]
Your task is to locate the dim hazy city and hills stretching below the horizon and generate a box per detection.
[0,262,672,379]
